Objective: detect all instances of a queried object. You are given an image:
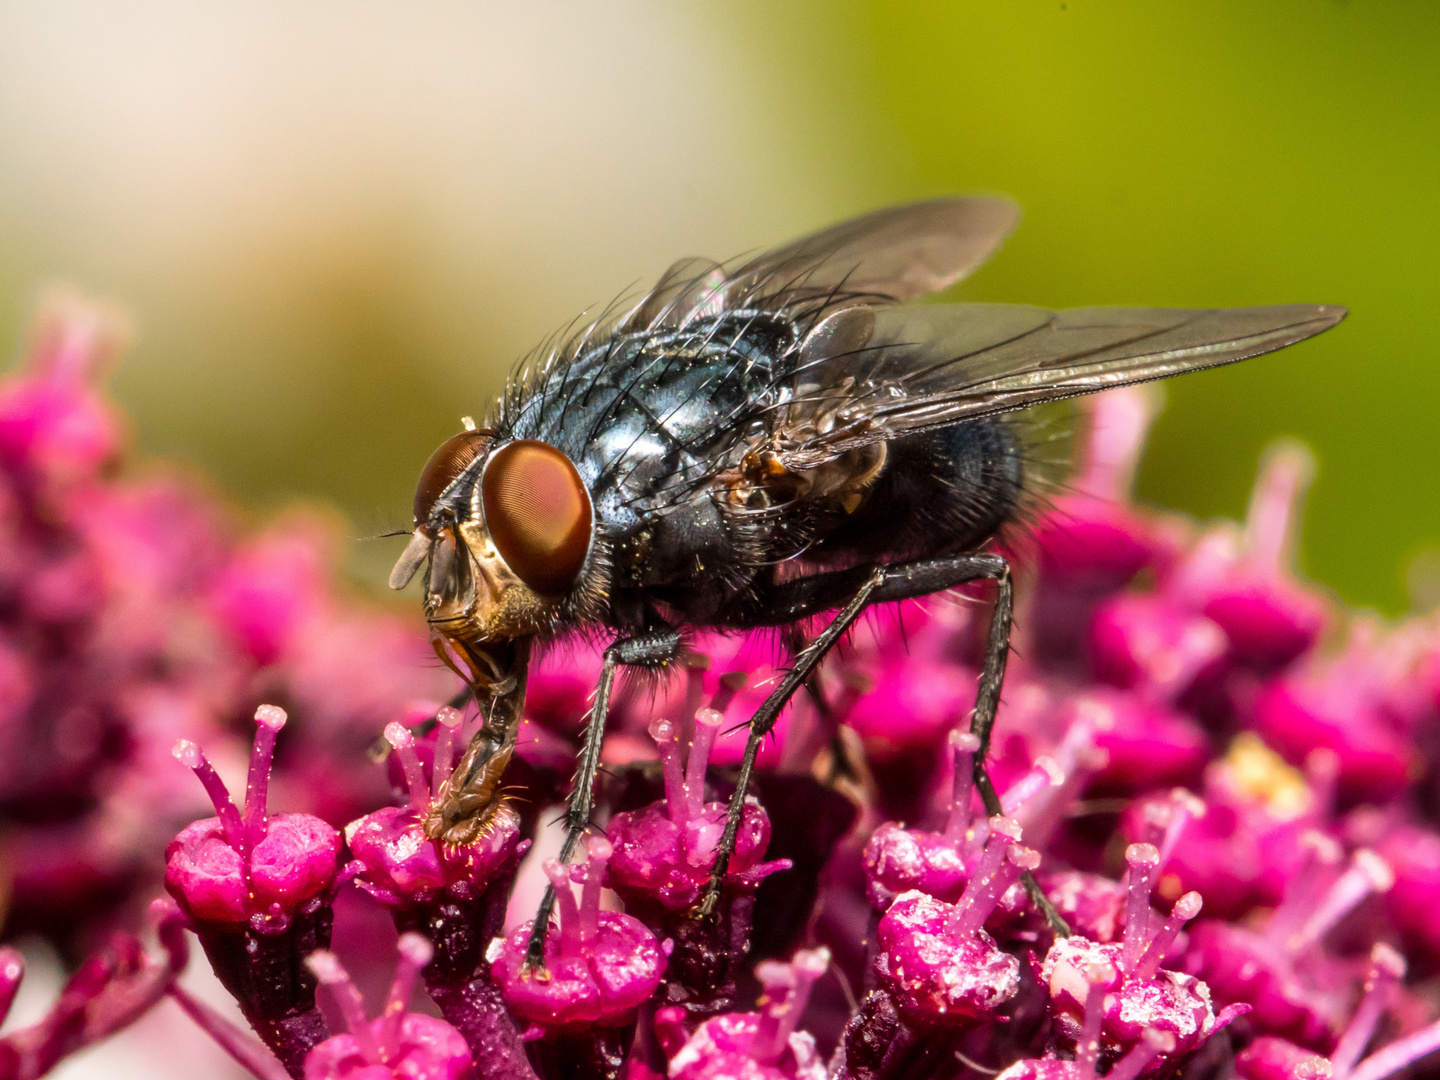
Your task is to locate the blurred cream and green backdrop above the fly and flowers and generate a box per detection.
[0,0,1440,612]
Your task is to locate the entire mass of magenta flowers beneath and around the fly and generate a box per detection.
[8,302,1440,1080]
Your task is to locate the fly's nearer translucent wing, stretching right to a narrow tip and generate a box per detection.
[769,304,1345,472]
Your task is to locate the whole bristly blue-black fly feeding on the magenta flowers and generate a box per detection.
[390,199,1345,962]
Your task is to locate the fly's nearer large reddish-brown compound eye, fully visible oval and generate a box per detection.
[481,439,592,596]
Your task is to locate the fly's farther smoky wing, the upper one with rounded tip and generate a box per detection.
[619,199,1020,333]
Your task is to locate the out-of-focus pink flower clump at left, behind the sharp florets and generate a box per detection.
[0,294,451,955]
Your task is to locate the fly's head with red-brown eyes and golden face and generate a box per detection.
[390,428,599,696]
